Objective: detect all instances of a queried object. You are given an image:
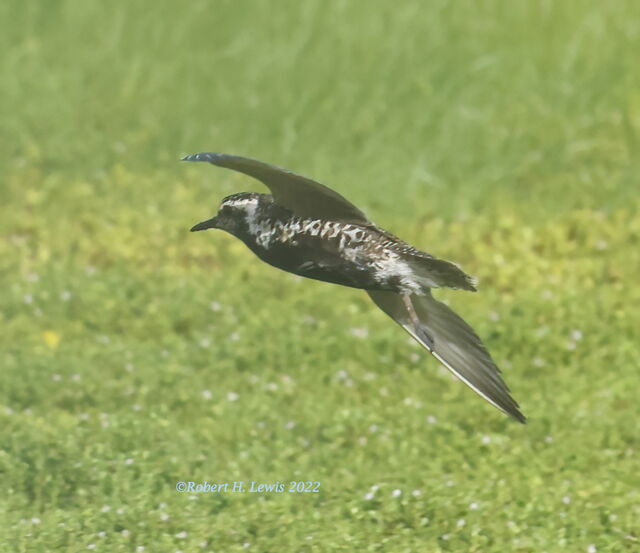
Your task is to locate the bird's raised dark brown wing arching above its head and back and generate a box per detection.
[182,152,369,223]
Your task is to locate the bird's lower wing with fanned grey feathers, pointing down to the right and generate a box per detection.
[368,291,526,423]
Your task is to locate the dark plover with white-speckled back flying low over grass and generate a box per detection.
[182,152,526,424]
